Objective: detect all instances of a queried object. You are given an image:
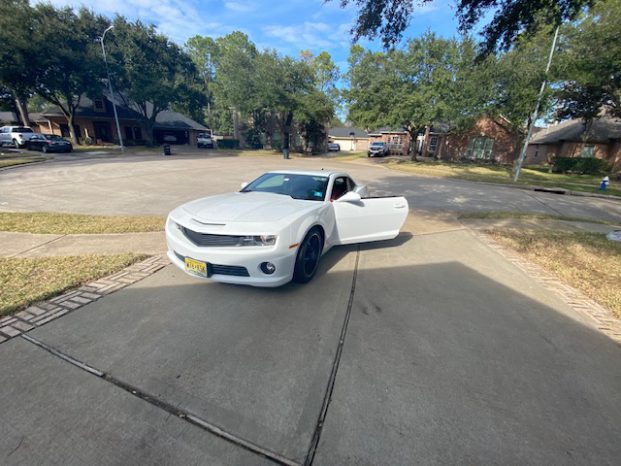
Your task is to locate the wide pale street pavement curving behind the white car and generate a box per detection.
[0,151,621,222]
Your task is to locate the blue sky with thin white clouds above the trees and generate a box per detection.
[35,0,457,72]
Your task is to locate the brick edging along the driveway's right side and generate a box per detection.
[473,231,621,345]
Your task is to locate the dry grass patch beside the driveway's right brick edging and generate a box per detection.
[488,230,621,318]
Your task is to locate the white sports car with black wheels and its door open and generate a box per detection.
[166,171,409,287]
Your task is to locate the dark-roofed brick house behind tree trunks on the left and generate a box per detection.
[31,96,207,145]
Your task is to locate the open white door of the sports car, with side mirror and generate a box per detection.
[332,192,409,244]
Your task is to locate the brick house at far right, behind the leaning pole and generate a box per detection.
[525,117,621,171]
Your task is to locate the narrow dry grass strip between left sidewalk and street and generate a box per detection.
[0,212,166,235]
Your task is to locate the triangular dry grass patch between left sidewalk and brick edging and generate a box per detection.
[0,253,147,316]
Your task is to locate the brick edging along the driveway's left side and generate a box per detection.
[0,254,170,343]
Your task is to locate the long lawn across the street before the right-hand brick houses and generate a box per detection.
[383,160,621,196]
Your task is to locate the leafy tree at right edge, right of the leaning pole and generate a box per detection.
[557,0,621,123]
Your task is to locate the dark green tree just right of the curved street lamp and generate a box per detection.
[109,17,197,144]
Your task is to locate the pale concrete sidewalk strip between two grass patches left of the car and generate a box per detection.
[0,231,166,257]
